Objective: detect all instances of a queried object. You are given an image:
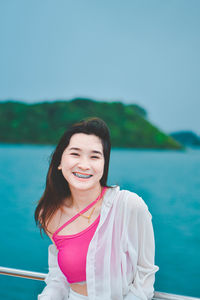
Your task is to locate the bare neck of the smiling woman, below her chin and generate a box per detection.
[70,184,102,210]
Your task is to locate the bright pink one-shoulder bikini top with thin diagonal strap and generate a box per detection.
[52,187,107,283]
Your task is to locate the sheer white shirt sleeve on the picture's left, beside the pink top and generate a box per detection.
[38,245,69,300]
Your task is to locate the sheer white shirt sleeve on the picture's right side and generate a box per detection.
[125,204,159,300]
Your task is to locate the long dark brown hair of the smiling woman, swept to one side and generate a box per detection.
[35,118,111,233]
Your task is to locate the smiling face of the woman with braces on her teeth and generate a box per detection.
[58,133,104,190]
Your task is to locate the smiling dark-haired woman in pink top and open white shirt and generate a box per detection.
[35,118,158,300]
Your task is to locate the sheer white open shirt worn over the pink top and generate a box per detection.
[38,186,158,300]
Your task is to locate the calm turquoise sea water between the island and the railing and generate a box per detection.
[0,145,200,300]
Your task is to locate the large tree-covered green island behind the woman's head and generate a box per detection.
[0,98,183,150]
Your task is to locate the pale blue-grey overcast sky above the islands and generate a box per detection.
[0,0,200,134]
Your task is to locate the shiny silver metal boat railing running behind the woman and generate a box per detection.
[0,267,200,300]
